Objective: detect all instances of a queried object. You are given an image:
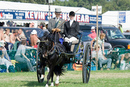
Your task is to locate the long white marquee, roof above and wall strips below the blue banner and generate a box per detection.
[0,1,94,27]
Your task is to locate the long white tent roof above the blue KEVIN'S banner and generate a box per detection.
[0,1,93,14]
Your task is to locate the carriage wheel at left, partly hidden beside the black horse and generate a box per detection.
[36,43,44,83]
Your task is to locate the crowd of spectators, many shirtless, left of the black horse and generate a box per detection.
[0,28,39,72]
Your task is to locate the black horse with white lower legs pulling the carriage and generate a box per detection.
[38,31,70,87]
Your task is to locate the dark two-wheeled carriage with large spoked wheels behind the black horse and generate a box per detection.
[37,28,91,83]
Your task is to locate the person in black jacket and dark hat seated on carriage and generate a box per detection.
[64,11,79,52]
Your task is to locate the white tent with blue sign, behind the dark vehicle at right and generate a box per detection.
[102,11,130,31]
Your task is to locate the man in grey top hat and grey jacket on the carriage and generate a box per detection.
[48,8,65,34]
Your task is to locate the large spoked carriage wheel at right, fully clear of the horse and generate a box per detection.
[82,44,91,83]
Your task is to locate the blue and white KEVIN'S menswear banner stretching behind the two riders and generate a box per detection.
[0,10,102,24]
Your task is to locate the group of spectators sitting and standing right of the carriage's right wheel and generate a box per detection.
[88,26,130,70]
